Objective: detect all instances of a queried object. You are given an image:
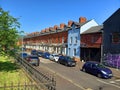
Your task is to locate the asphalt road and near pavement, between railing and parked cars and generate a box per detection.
[39,58,120,90]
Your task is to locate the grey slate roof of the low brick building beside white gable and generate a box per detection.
[81,25,103,34]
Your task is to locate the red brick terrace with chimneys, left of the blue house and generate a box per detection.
[24,23,70,55]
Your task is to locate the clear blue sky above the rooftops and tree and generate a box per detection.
[0,0,120,33]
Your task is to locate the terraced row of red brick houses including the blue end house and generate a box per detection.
[23,17,98,59]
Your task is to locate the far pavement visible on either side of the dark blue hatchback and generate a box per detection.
[76,61,120,79]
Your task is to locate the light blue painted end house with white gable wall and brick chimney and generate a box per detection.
[68,17,98,60]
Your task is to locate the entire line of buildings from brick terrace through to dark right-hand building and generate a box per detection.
[23,9,120,67]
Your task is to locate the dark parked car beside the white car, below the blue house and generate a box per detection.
[58,56,76,66]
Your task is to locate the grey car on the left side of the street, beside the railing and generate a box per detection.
[25,55,40,66]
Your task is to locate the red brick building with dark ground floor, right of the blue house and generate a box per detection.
[80,26,103,62]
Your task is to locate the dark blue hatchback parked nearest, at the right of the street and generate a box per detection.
[82,61,113,78]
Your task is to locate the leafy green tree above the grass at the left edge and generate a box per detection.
[0,8,20,54]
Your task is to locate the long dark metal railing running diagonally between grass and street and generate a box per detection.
[15,55,56,90]
